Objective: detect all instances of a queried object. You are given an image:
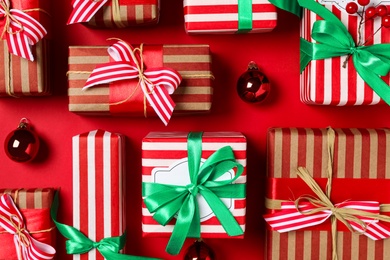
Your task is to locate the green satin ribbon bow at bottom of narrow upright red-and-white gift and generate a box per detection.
[50,192,158,260]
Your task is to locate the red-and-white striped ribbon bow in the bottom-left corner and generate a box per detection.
[0,194,56,260]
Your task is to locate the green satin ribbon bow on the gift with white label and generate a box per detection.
[142,133,246,255]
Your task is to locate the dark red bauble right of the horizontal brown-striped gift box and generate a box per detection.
[237,61,271,103]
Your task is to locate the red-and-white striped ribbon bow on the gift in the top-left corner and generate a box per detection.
[0,0,47,61]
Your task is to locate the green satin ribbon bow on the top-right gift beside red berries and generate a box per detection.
[298,0,390,105]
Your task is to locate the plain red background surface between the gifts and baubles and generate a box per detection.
[0,0,390,260]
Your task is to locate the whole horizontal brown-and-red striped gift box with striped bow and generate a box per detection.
[68,41,213,124]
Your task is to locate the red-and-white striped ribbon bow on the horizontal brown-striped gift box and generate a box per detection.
[83,40,182,125]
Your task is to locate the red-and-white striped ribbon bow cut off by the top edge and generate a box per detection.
[67,0,125,27]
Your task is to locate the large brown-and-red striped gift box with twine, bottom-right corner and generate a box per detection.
[264,128,390,259]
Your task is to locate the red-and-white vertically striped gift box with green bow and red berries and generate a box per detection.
[300,0,390,106]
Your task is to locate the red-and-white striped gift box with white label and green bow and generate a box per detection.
[142,132,246,254]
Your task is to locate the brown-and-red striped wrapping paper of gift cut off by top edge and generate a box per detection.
[88,0,160,28]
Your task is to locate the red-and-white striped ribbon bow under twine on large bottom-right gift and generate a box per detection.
[264,201,390,240]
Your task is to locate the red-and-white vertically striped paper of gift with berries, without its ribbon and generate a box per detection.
[300,3,390,106]
